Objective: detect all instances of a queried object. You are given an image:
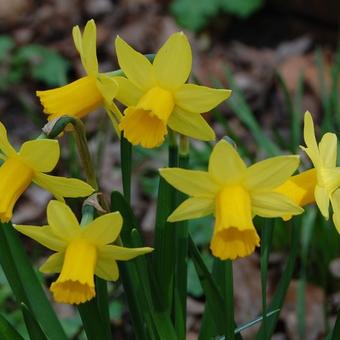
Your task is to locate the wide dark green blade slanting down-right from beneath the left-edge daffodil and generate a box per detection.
[0,223,67,340]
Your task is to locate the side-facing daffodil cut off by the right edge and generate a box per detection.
[277,111,340,233]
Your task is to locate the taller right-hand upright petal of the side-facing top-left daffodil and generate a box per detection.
[82,19,98,75]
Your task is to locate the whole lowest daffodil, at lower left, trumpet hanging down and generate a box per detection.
[15,201,153,304]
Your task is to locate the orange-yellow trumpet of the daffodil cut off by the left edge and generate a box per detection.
[0,156,34,222]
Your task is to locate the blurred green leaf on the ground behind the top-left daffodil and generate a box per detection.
[16,44,70,86]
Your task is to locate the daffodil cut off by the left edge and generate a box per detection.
[0,123,94,222]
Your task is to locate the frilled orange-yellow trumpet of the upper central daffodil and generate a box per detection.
[119,87,175,148]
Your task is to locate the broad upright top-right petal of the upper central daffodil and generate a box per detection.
[153,32,192,90]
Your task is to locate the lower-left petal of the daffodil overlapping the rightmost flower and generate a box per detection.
[168,197,215,222]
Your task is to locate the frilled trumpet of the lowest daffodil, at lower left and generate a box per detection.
[50,239,97,304]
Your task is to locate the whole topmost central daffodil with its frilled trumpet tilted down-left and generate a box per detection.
[115,32,231,148]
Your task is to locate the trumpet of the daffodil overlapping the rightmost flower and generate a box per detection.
[210,185,260,260]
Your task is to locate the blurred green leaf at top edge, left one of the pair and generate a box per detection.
[170,0,219,31]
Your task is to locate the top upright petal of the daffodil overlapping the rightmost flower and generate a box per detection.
[209,140,246,184]
